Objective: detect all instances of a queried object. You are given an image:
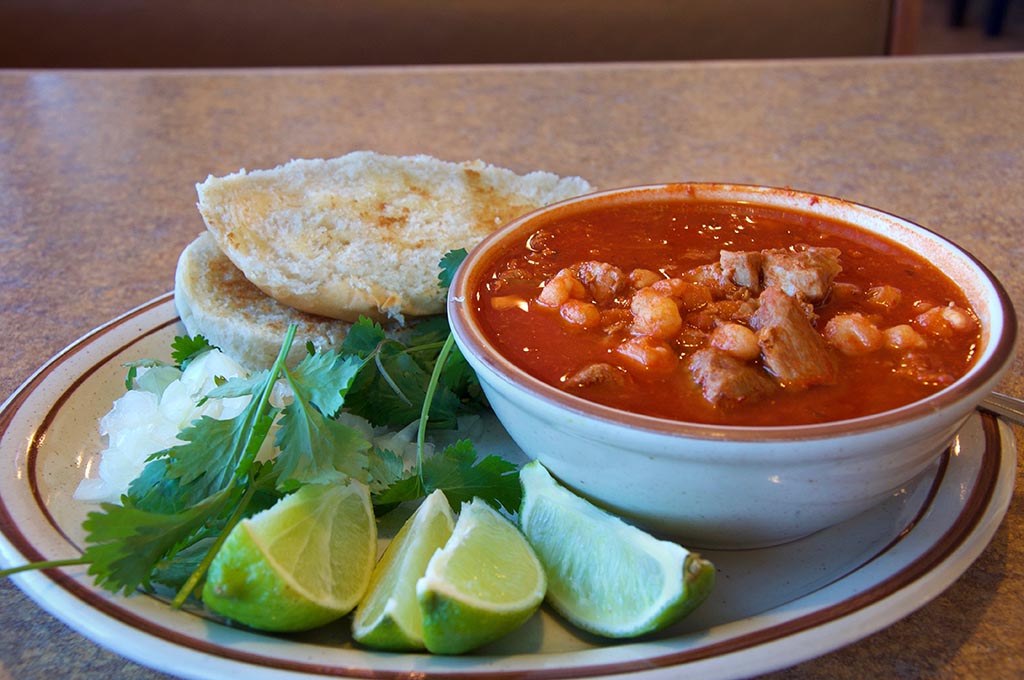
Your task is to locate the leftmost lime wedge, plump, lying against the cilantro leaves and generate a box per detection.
[203,481,377,631]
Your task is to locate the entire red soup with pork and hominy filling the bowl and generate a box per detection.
[474,201,980,426]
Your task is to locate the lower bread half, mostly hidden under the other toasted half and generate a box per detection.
[174,231,351,370]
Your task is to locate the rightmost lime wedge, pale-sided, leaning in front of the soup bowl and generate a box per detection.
[519,461,715,638]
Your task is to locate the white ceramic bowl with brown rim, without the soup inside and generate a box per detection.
[447,184,1017,548]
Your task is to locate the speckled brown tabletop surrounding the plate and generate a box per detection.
[0,54,1024,680]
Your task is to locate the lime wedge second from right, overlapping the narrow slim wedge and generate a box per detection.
[416,499,545,654]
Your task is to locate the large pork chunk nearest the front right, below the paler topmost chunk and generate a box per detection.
[751,286,836,388]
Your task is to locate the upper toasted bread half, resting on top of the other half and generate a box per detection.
[197,152,593,321]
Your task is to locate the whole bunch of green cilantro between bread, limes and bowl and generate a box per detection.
[0,250,521,606]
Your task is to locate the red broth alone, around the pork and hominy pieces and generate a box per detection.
[475,202,980,426]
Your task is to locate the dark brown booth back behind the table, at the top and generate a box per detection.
[0,0,922,68]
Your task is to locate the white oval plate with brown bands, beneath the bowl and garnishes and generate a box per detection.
[0,295,1016,679]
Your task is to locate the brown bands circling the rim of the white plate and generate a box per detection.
[0,294,1002,679]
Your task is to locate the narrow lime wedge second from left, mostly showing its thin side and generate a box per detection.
[352,490,455,651]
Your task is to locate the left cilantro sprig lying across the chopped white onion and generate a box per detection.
[83,326,370,606]
